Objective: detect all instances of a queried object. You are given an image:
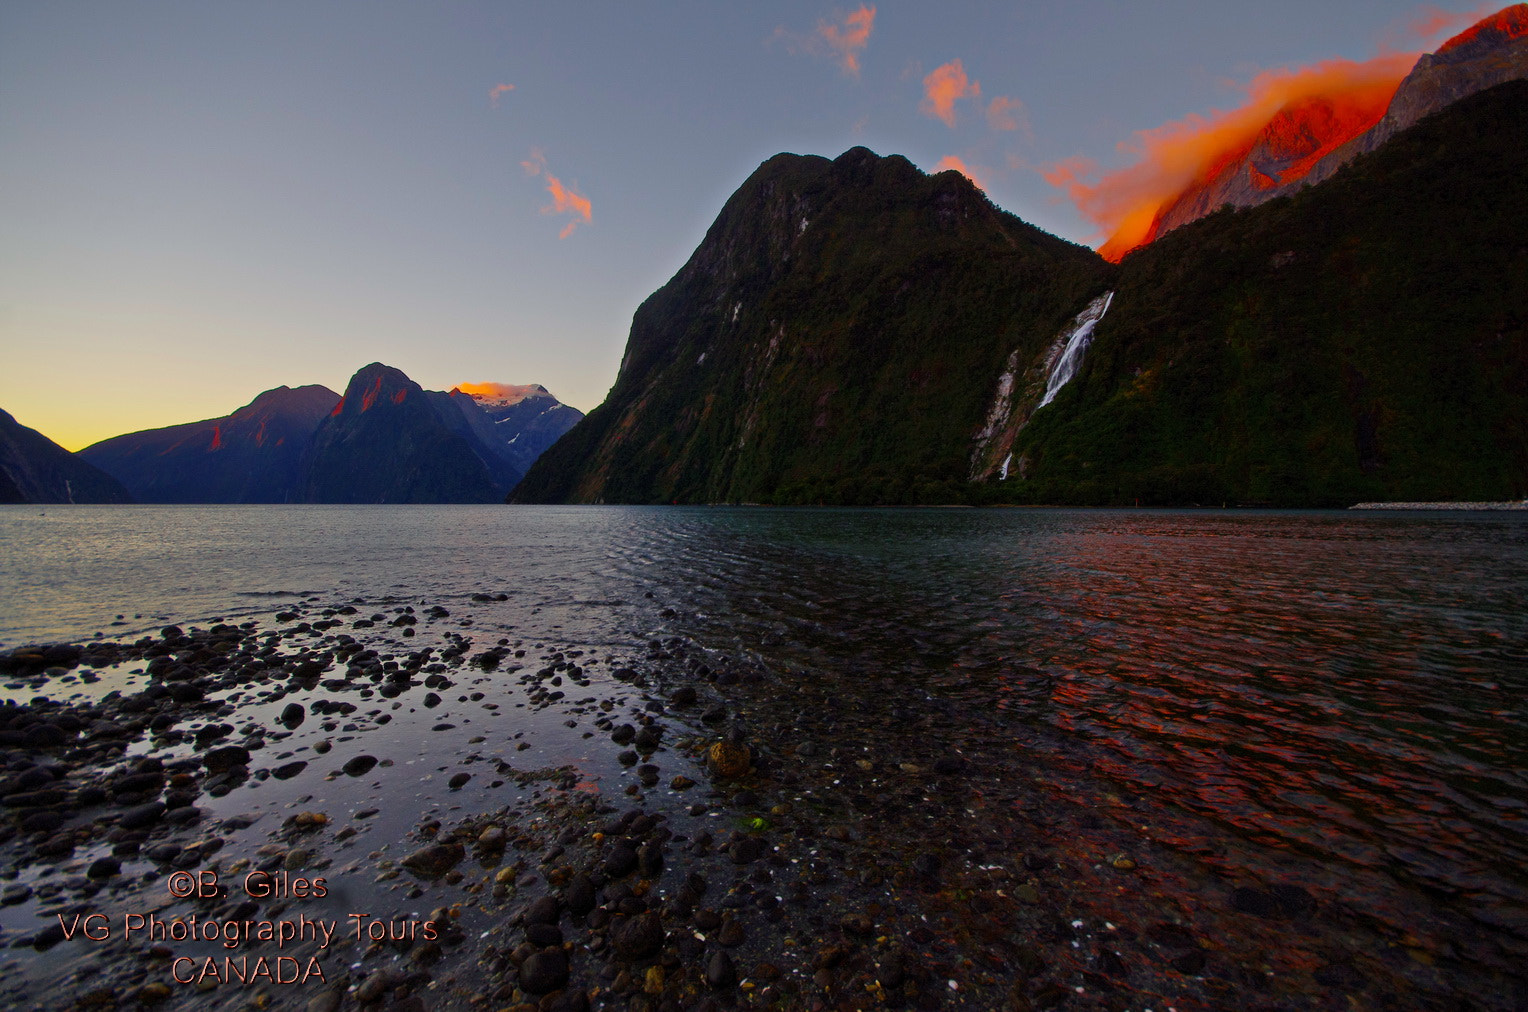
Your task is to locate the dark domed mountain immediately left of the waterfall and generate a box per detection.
[513,148,1109,503]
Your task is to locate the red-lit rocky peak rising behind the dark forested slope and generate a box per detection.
[1144,3,1528,252]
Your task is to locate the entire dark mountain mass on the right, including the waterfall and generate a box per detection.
[512,5,1528,506]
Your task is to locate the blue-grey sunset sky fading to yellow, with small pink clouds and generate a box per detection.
[0,0,1499,449]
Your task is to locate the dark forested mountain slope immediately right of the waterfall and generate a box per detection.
[1002,81,1528,506]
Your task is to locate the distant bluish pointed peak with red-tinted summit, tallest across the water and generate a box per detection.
[298,362,521,503]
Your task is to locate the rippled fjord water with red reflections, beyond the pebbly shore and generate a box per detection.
[0,506,1528,978]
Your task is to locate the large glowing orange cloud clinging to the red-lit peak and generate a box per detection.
[1042,54,1416,260]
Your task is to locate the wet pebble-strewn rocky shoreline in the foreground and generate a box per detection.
[0,595,1528,1012]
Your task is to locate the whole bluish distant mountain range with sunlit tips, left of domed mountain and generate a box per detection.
[59,362,584,503]
